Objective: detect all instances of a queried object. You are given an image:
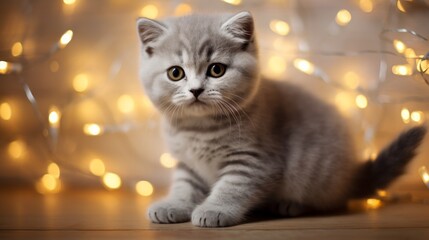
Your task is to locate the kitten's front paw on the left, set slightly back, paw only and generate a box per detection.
[148,201,193,223]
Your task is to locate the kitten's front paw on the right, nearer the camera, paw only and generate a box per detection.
[192,203,242,227]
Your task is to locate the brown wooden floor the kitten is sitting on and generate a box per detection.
[0,189,429,240]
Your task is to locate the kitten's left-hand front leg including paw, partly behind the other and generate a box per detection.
[148,163,209,223]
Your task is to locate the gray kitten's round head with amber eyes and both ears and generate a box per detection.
[137,12,259,116]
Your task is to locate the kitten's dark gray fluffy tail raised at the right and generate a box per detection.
[353,126,426,198]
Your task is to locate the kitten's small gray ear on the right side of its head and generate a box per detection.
[221,12,254,43]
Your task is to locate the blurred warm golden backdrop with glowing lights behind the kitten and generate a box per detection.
[0,0,429,196]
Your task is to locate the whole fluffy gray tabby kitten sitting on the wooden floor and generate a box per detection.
[138,12,426,227]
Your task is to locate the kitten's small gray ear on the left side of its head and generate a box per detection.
[137,18,167,44]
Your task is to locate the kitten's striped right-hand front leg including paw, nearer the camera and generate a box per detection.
[192,160,275,227]
